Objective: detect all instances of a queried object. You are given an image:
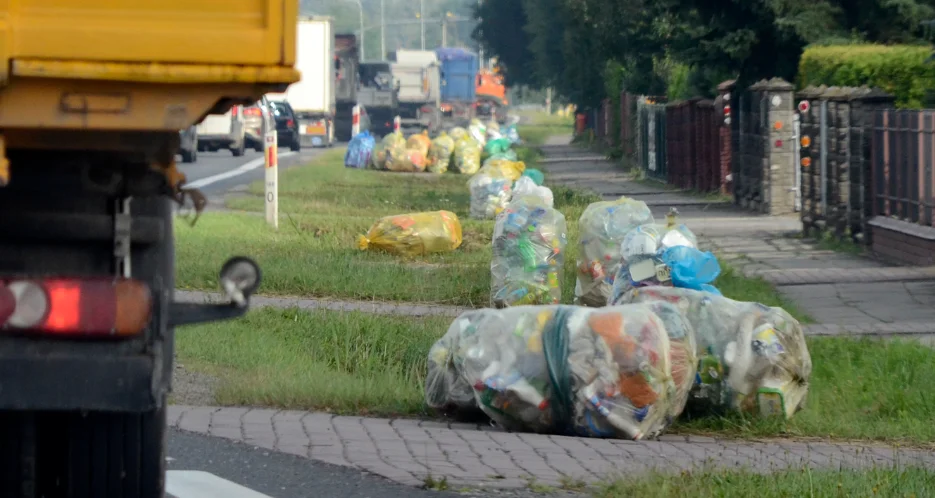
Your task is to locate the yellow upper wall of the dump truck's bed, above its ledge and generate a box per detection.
[0,0,298,67]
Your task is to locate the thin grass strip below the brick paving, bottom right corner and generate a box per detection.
[592,467,935,498]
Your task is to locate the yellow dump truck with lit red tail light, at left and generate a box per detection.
[0,0,299,498]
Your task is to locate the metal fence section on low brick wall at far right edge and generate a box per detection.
[871,110,935,227]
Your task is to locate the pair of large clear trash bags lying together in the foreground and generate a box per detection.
[425,287,812,440]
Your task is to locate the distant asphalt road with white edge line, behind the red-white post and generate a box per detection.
[177,144,343,197]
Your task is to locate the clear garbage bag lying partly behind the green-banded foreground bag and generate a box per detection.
[622,287,812,418]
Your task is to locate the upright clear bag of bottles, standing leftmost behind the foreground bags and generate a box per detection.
[490,193,568,308]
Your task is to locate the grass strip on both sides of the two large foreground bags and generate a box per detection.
[176,309,935,446]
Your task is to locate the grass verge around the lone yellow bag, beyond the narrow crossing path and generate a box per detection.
[176,117,807,320]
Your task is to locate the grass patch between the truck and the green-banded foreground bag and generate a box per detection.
[176,308,449,415]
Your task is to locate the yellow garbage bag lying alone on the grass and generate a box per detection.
[357,211,461,256]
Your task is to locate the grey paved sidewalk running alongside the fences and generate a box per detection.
[542,137,935,334]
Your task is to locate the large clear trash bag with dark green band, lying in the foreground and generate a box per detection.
[425,302,697,440]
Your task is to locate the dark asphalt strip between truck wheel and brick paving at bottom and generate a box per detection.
[167,429,573,498]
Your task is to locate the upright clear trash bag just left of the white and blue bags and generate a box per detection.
[575,197,653,307]
